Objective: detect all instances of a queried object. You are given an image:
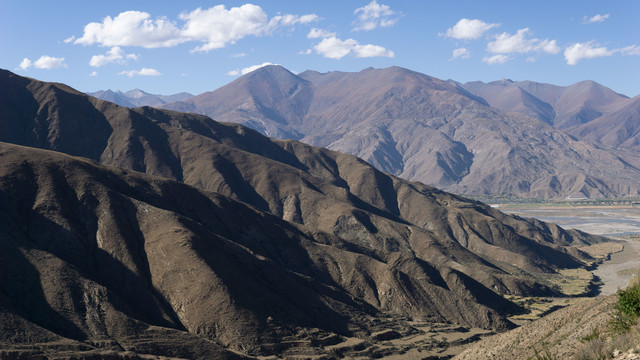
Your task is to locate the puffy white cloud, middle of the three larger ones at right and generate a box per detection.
[487,28,560,54]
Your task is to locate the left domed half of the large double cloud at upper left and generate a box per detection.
[74,11,186,48]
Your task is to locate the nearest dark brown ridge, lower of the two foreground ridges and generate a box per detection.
[0,144,524,358]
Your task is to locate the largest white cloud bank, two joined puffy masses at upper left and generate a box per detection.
[74,4,320,52]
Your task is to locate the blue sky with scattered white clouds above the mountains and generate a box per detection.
[0,0,640,97]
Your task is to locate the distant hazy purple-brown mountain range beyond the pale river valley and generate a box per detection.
[161,66,640,198]
